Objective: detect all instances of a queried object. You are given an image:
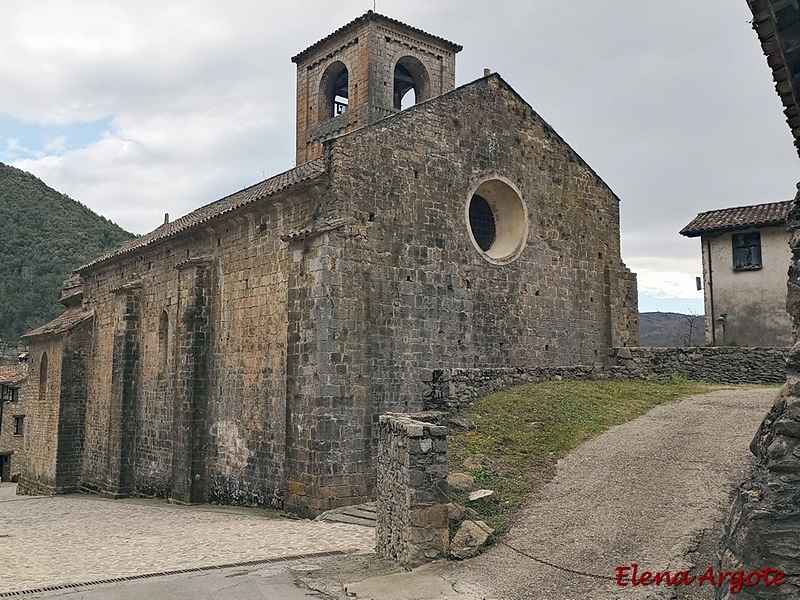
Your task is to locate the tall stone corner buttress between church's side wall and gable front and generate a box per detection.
[284,232,378,517]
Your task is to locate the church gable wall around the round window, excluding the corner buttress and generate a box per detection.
[330,76,636,411]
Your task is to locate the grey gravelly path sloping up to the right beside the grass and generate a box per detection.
[444,389,777,600]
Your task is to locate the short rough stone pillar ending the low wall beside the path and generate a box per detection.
[375,413,450,569]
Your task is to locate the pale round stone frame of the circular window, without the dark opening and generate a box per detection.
[464,175,528,265]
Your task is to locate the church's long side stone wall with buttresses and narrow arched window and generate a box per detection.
[80,179,316,508]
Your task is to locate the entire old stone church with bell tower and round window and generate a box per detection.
[20,11,638,515]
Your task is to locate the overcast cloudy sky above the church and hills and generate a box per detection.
[0,0,800,313]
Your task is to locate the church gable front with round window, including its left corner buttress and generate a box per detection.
[287,77,636,515]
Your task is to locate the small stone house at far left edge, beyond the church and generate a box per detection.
[0,364,26,481]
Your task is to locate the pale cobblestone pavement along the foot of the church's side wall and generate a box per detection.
[0,483,375,593]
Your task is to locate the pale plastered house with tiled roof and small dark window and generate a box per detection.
[681,200,792,347]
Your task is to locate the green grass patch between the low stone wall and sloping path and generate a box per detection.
[448,378,731,531]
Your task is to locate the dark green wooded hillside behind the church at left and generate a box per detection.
[0,163,134,342]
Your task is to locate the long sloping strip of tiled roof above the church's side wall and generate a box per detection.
[75,158,325,272]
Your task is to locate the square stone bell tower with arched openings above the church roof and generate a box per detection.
[292,11,461,165]
